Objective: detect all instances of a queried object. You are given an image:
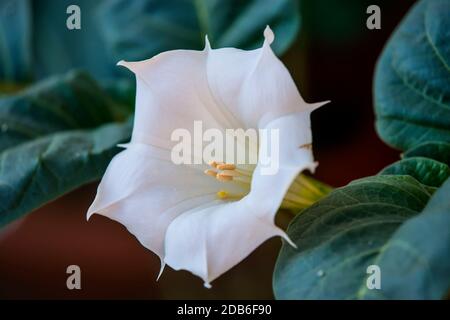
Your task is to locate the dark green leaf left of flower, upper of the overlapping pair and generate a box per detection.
[0,71,125,152]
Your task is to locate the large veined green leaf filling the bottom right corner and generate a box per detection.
[274,175,450,299]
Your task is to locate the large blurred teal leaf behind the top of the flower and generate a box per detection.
[33,0,299,79]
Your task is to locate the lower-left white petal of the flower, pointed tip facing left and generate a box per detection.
[88,144,241,259]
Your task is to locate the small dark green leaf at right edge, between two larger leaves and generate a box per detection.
[380,157,450,187]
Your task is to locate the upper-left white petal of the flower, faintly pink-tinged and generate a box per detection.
[119,50,237,149]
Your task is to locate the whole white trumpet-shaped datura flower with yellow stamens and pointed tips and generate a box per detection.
[87,27,326,287]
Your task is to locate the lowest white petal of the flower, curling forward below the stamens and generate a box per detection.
[164,198,284,287]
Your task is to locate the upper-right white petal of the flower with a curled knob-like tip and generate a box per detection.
[207,27,326,128]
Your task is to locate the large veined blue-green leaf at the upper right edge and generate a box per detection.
[374,0,450,150]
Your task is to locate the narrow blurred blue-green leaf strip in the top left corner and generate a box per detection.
[0,0,32,82]
